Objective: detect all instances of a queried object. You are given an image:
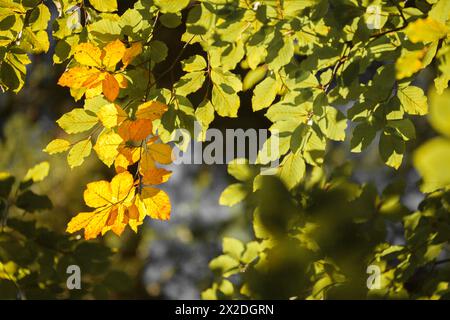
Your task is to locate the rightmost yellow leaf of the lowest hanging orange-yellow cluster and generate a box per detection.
[138,187,170,220]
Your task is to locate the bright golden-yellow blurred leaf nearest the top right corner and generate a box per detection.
[405,17,450,43]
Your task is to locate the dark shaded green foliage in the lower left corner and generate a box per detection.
[0,166,127,299]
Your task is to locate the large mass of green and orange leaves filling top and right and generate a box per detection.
[0,0,450,298]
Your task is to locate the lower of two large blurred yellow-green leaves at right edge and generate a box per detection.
[413,138,450,192]
